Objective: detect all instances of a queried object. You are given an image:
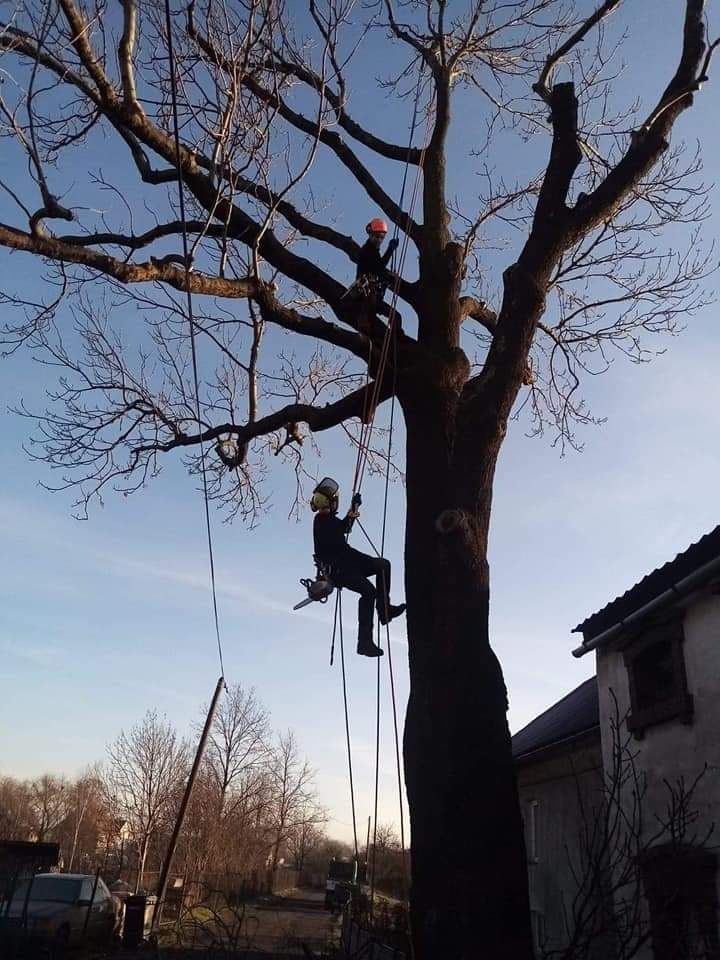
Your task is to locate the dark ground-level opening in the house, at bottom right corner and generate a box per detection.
[641,844,720,960]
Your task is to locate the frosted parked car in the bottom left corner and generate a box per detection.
[7,873,118,945]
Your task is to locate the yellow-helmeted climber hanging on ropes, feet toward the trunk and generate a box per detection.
[310,477,405,657]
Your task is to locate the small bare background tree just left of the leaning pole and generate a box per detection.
[104,711,188,891]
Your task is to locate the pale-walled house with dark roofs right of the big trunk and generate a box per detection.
[513,527,720,960]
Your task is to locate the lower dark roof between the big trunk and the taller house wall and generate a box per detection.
[512,677,600,760]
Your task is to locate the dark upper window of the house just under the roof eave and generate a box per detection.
[624,620,693,739]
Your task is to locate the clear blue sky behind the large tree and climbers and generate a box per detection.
[0,0,720,838]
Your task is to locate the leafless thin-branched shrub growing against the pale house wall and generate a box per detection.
[541,691,720,960]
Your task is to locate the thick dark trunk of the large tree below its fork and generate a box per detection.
[404,389,533,960]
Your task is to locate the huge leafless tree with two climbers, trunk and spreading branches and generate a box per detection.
[0,0,715,960]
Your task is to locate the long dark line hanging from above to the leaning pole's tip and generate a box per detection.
[165,0,225,676]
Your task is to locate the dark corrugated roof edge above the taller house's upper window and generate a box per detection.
[573,526,720,642]
